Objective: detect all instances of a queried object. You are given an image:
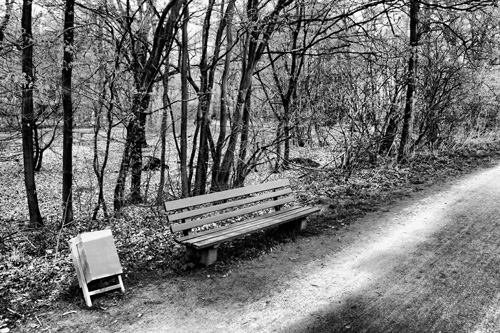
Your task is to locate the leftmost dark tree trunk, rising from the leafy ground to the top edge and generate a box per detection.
[21,0,43,228]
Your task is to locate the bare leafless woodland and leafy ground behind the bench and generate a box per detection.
[0,0,500,328]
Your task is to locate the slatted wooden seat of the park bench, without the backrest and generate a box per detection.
[183,207,319,249]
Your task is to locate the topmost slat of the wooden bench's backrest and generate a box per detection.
[165,179,290,211]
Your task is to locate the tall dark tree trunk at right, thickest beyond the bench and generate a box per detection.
[398,0,420,163]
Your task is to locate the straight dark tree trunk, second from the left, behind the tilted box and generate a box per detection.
[61,0,75,225]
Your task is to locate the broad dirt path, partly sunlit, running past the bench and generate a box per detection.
[41,166,500,333]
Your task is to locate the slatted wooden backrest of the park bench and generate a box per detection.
[165,179,295,232]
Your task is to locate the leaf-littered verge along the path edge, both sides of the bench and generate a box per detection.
[0,142,500,328]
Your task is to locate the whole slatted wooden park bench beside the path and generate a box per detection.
[165,179,320,266]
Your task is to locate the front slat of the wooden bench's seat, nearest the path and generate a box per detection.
[190,208,319,249]
